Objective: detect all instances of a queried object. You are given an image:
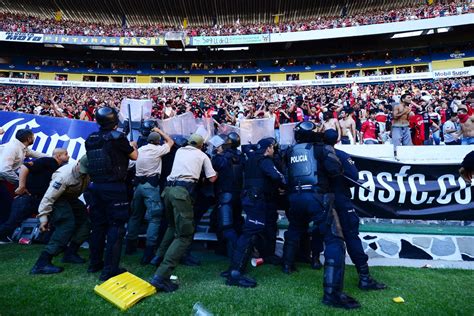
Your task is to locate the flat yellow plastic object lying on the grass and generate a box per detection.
[94,272,156,311]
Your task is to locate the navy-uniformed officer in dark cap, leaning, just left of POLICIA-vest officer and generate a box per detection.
[222,138,286,287]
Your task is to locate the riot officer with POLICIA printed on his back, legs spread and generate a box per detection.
[283,122,360,309]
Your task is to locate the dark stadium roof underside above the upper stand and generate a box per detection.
[0,0,423,26]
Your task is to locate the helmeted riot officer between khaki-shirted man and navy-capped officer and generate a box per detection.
[212,132,242,258]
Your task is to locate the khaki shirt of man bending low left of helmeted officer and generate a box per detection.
[37,163,90,223]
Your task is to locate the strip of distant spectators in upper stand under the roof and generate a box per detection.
[0,0,473,37]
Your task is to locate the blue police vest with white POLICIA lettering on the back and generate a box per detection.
[287,143,318,187]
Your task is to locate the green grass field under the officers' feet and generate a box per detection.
[0,245,474,316]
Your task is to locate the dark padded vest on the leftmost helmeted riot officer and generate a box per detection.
[85,131,127,183]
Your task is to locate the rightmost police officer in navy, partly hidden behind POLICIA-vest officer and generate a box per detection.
[324,129,386,290]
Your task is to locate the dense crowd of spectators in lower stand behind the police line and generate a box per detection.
[0,77,474,145]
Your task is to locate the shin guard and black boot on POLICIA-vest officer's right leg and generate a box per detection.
[323,259,360,309]
